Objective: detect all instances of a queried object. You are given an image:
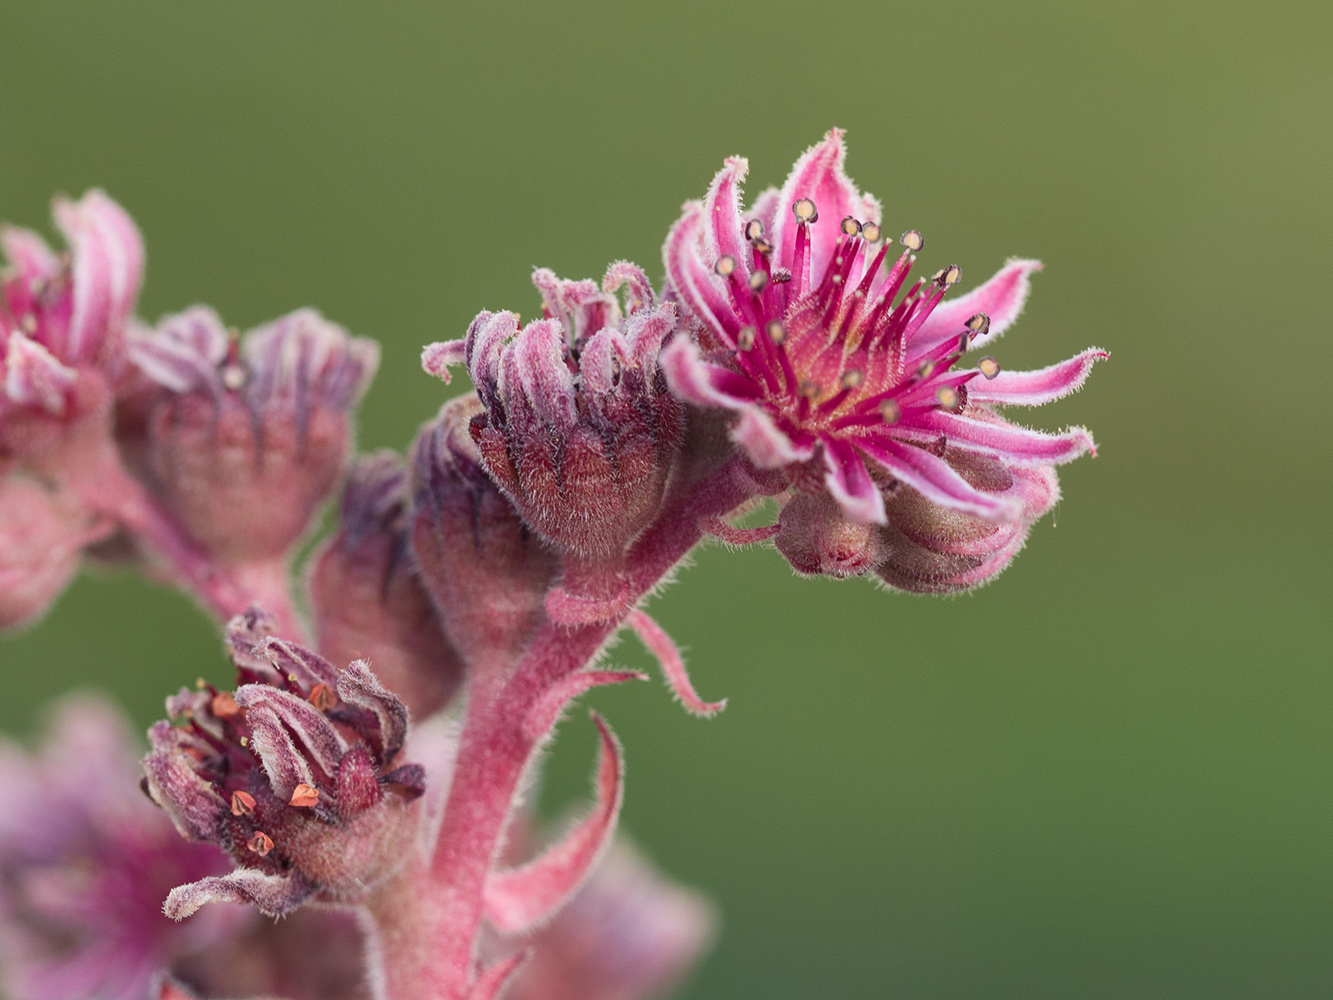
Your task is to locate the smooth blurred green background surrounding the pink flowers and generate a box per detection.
[0,0,1333,1000]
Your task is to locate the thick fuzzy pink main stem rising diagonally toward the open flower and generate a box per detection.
[371,464,754,1000]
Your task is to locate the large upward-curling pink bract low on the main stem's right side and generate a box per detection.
[485,712,624,935]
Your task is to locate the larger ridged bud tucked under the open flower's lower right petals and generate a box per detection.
[874,432,1060,593]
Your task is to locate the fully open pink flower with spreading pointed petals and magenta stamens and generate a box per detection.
[663,129,1106,524]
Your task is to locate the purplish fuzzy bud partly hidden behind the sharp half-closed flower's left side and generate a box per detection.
[412,393,559,661]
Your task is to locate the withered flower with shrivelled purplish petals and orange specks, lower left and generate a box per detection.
[144,612,423,920]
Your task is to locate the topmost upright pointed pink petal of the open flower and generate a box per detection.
[773,128,880,283]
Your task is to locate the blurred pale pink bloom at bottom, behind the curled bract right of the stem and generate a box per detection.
[495,840,717,1000]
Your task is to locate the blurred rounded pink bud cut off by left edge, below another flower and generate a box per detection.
[0,472,109,628]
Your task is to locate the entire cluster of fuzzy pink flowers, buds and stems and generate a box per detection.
[0,129,1106,1000]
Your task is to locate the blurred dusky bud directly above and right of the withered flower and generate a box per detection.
[309,452,463,719]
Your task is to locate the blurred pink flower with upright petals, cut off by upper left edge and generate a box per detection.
[0,191,144,469]
